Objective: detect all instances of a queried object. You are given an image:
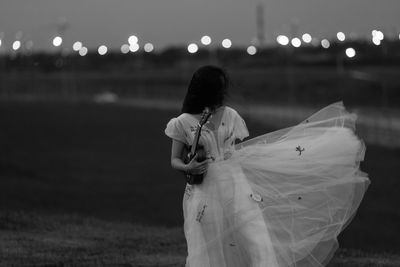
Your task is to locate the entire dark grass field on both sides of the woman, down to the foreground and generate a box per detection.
[0,102,400,266]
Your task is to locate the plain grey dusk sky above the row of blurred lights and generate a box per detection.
[0,0,400,50]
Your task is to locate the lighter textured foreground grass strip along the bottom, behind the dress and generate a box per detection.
[0,212,400,267]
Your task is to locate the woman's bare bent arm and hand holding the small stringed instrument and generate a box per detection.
[171,139,207,174]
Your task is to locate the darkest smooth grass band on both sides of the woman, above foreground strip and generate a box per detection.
[0,102,400,260]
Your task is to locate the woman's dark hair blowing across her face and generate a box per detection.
[181,65,229,114]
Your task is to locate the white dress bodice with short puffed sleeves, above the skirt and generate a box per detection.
[165,106,249,161]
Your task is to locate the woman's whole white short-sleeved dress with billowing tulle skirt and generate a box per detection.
[165,102,370,267]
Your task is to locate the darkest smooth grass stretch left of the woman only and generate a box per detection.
[0,103,184,225]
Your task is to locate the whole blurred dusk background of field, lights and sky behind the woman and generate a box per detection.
[0,0,400,266]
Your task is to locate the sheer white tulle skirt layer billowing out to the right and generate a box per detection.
[225,102,370,266]
